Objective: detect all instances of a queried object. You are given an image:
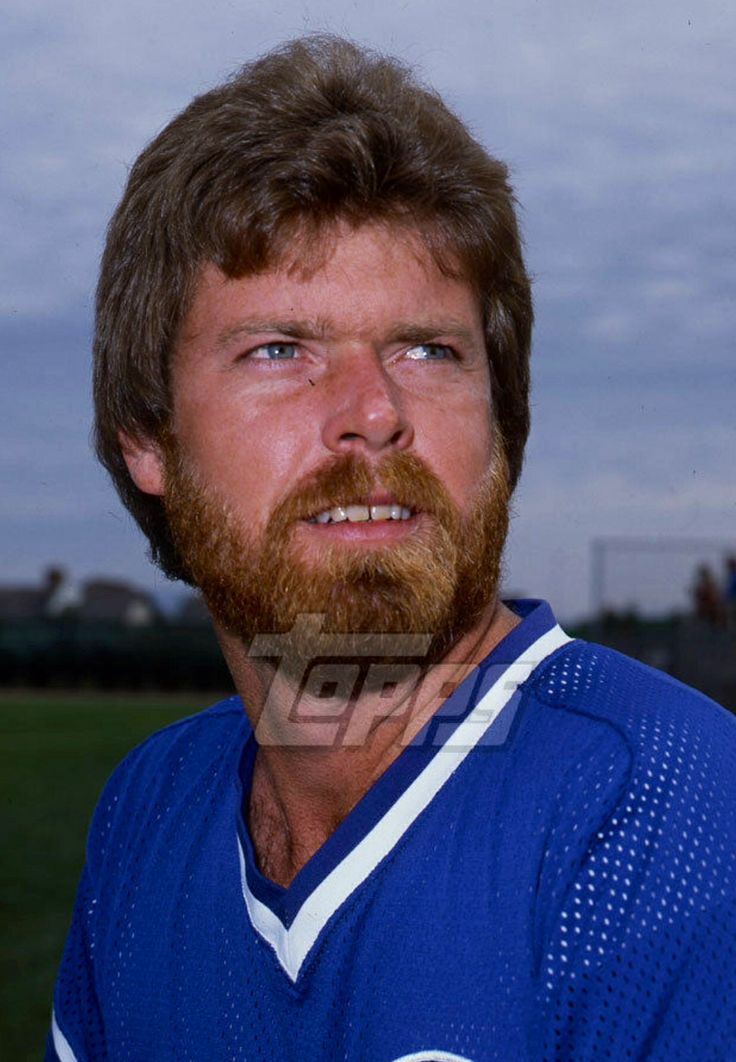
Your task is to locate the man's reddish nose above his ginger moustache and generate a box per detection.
[322,349,414,453]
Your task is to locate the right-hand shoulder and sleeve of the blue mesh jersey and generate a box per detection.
[533,643,736,1058]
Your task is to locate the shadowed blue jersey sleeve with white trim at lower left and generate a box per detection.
[46,867,107,1062]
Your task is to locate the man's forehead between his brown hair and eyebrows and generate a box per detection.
[177,224,482,347]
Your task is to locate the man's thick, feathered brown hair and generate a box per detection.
[95,36,532,578]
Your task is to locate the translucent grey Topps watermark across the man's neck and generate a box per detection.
[249,614,518,749]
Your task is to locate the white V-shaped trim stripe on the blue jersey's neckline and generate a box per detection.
[238,624,572,981]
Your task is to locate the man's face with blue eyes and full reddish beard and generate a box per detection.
[127,225,508,646]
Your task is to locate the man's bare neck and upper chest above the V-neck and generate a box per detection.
[218,602,519,887]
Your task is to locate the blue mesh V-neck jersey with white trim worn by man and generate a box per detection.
[47,602,736,1062]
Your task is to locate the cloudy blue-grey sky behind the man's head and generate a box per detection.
[0,0,736,617]
